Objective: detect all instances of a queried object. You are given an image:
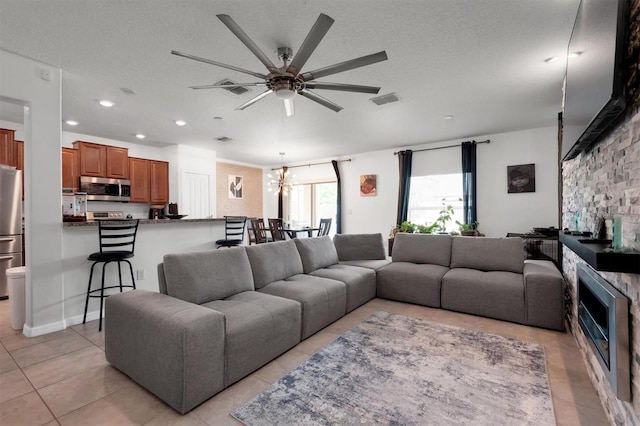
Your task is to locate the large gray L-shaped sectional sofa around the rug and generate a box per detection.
[105,234,563,413]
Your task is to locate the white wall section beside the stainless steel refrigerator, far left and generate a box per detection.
[0,50,64,335]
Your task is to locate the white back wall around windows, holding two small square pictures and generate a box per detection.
[264,123,558,238]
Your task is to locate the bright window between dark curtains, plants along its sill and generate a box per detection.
[408,173,464,232]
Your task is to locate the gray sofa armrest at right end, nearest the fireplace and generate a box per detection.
[523,260,564,330]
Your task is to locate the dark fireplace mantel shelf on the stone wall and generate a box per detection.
[560,233,640,274]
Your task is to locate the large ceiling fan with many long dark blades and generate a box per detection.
[171,13,387,117]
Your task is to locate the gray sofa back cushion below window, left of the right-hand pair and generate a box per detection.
[392,232,451,266]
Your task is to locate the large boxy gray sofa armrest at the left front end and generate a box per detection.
[105,290,226,414]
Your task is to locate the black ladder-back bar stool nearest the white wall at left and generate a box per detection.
[82,220,139,331]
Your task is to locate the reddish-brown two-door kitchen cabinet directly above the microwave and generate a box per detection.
[73,141,129,179]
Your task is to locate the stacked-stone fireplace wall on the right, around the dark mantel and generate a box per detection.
[562,0,640,425]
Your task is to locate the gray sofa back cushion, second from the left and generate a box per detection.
[245,240,304,289]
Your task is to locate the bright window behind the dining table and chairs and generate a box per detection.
[285,182,338,235]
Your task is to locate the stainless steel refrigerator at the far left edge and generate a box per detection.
[0,165,22,299]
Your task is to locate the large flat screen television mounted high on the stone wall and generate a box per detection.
[561,0,629,160]
